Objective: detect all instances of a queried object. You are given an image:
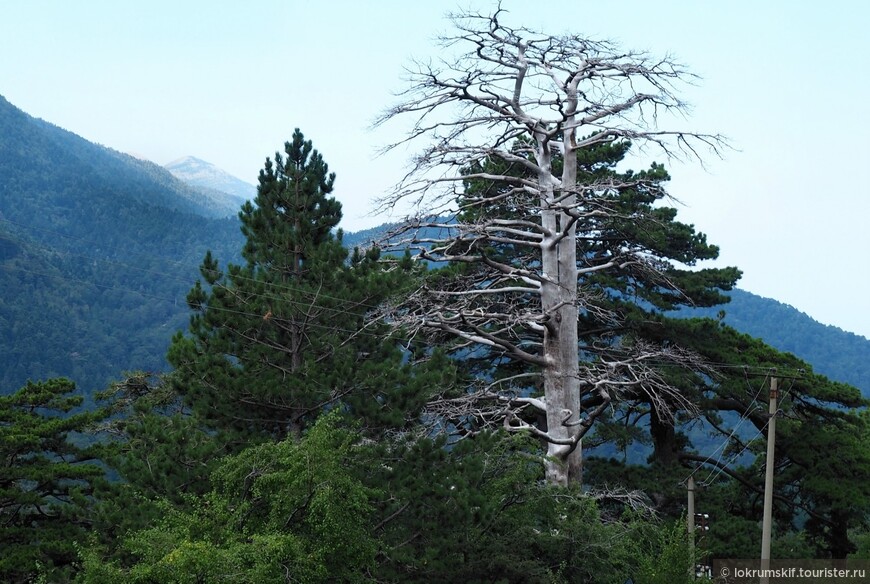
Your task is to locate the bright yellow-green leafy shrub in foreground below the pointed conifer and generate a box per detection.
[76,414,377,584]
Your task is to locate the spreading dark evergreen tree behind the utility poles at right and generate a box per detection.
[589,316,870,558]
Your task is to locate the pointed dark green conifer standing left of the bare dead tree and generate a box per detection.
[169,129,440,437]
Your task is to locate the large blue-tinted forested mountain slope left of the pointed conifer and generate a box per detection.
[0,97,242,394]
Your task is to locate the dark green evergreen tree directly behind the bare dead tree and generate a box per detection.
[418,139,740,460]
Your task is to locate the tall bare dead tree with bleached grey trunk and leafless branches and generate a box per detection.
[376,9,724,485]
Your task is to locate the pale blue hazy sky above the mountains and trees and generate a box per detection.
[0,0,870,337]
